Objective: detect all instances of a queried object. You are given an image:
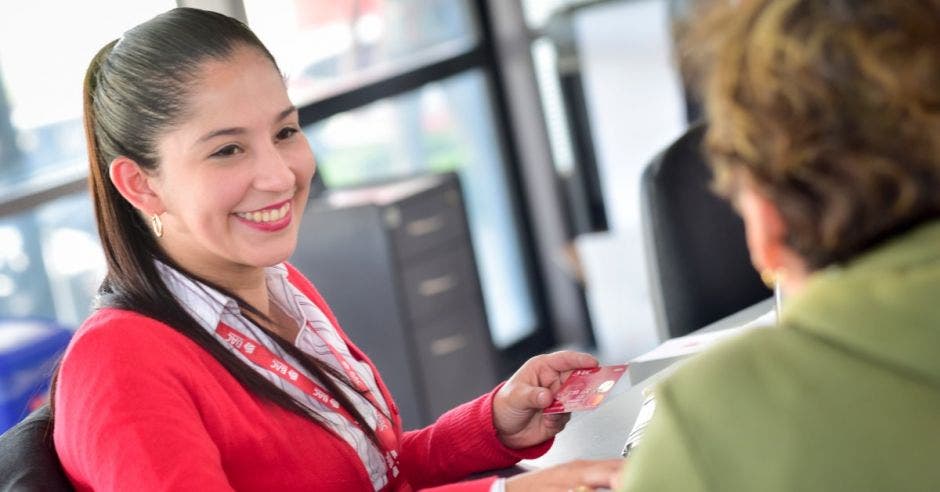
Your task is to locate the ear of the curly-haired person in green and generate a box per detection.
[737,185,789,272]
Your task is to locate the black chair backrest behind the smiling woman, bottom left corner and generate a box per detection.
[0,405,74,492]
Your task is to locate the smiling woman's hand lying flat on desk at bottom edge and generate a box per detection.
[506,459,624,492]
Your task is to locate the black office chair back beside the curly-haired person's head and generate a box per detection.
[640,123,773,340]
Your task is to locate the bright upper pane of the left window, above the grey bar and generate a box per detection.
[0,0,176,188]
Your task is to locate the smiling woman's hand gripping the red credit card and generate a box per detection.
[493,351,597,449]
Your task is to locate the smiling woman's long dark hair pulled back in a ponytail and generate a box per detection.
[74,8,376,442]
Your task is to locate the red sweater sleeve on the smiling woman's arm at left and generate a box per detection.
[54,312,232,491]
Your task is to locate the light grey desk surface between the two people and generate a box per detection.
[519,299,774,470]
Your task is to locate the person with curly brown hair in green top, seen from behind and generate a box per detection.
[618,0,940,492]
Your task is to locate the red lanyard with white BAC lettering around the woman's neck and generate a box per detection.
[215,323,408,490]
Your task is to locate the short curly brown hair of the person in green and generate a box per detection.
[680,0,940,269]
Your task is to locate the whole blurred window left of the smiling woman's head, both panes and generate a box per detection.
[0,0,176,326]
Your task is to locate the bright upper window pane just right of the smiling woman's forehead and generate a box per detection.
[245,0,477,105]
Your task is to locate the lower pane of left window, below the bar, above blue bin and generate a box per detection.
[0,193,105,326]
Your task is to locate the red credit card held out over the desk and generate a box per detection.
[542,364,627,414]
